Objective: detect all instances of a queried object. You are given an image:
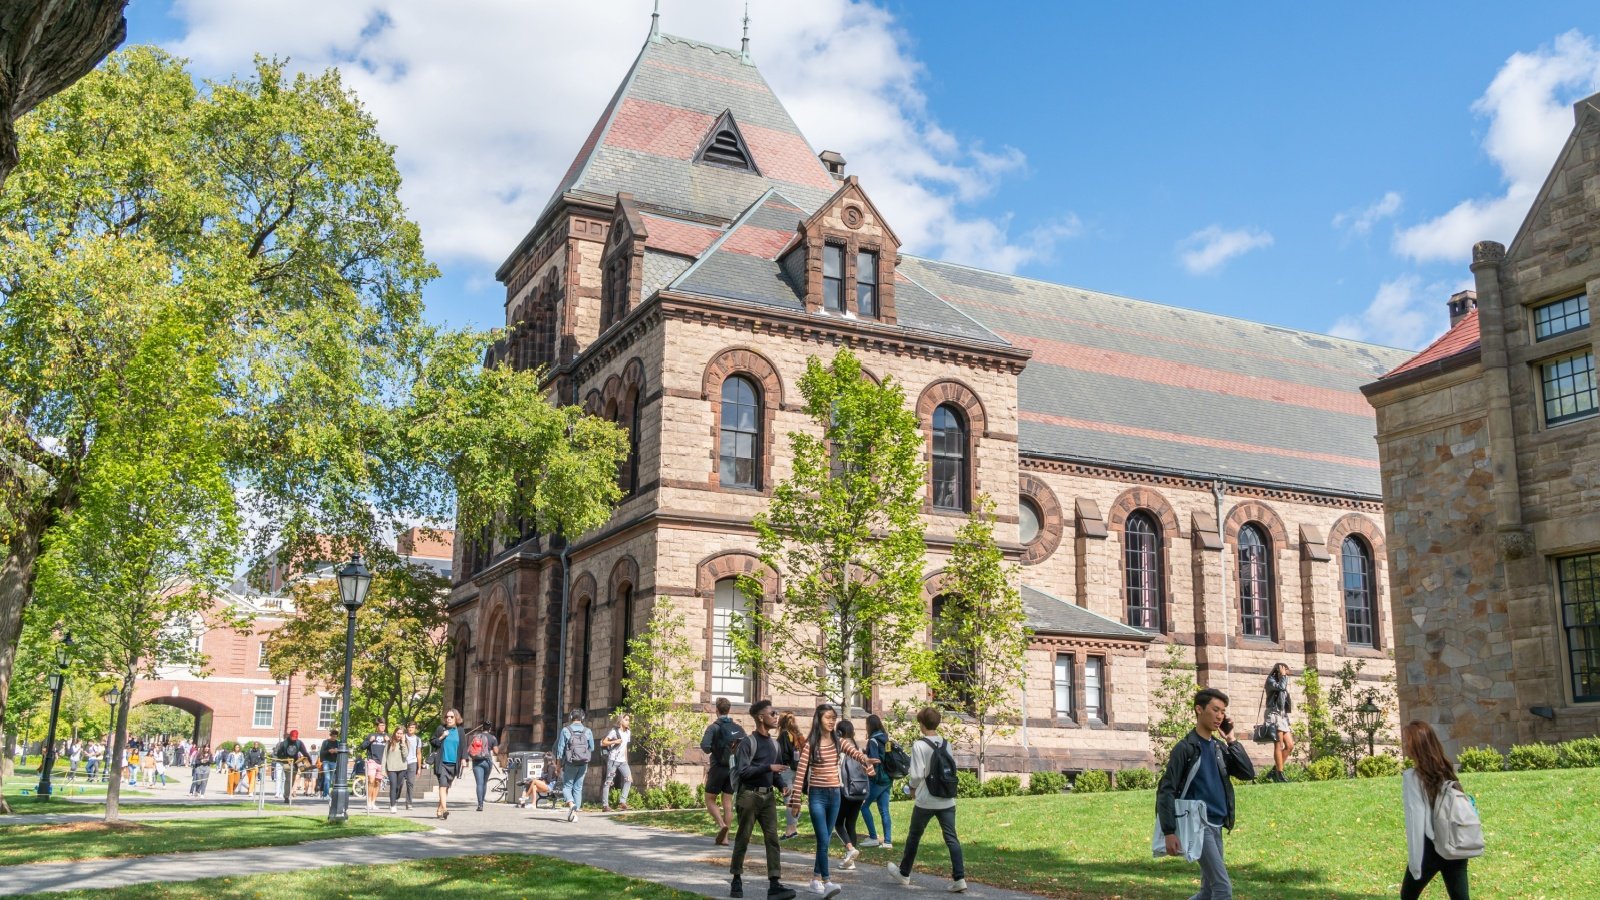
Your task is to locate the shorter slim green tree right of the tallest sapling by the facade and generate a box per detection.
[918,495,1034,778]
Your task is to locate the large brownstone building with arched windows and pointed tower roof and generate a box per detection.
[446,24,1408,772]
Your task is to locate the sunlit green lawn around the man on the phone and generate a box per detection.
[626,769,1600,900]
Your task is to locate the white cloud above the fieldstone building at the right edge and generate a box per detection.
[1394,30,1600,263]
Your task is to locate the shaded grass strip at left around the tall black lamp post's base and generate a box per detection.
[0,815,429,866]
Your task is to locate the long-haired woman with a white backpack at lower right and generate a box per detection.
[1400,721,1483,900]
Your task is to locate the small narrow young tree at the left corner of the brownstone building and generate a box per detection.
[622,597,701,788]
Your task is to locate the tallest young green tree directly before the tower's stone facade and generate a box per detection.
[731,348,928,709]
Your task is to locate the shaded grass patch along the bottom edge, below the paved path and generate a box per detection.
[12,855,697,900]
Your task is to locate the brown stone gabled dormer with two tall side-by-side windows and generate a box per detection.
[782,175,899,325]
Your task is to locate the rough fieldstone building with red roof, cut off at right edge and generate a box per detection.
[1363,94,1600,751]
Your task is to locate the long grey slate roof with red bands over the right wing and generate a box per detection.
[901,256,1406,496]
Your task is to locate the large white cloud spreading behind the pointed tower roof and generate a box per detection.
[162,0,1066,277]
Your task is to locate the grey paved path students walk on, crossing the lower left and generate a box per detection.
[0,794,1034,900]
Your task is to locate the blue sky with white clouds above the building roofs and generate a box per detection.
[128,0,1600,346]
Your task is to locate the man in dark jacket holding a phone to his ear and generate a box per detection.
[1155,687,1256,900]
